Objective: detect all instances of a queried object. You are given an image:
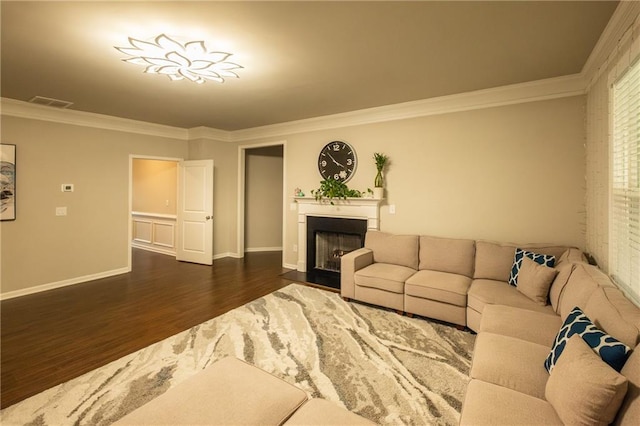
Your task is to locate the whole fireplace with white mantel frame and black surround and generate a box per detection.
[294,197,383,288]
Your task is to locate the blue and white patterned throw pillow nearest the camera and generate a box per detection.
[544,306,631,374]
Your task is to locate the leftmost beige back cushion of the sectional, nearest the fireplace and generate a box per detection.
[364,230,418,269]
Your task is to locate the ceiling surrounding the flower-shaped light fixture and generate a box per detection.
[0,1,617,130]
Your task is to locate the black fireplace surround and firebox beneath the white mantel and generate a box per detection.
[307,216,367,288]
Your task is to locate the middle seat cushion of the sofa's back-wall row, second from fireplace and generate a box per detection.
[405,270,471,306]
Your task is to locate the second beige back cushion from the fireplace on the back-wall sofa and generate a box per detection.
[419,236,476,278]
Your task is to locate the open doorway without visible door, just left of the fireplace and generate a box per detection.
[238,142,286,262]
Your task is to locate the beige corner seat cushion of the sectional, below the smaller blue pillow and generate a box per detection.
[467,279,554,314]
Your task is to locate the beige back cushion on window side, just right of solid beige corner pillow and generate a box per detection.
[558,263,613,321]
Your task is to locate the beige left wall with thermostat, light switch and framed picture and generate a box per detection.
[0,116,187,294]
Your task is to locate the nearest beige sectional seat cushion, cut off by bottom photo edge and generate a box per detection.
[460,380,563,426]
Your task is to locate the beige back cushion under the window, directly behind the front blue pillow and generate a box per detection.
[584,287,640,348]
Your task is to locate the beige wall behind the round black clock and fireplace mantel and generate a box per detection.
[239,96,585,265]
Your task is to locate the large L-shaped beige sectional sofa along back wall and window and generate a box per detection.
[341,231,640,425]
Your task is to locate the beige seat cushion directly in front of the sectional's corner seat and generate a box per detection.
[478,305,562,348]
